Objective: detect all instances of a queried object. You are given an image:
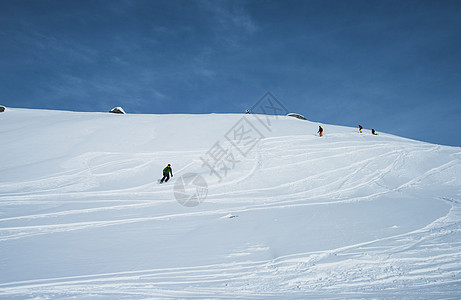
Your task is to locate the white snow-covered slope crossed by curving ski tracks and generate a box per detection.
[0,109,461,299]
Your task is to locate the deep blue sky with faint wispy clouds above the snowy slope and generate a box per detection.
[0,0,461,146]
